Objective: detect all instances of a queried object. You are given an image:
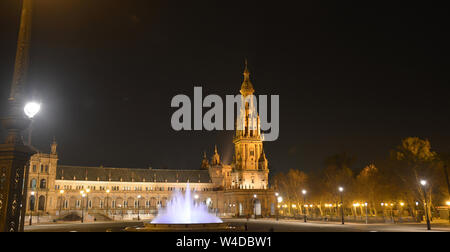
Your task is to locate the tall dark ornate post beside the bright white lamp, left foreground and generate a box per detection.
[0,0,33,232]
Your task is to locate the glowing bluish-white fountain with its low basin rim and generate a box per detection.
[125,184,232,232]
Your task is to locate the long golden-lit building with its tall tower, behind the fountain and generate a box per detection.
[27,64,275,219]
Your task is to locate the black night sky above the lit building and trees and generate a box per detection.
[0,0,450,172]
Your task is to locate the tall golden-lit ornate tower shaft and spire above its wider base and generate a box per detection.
[233,60,269,189]
